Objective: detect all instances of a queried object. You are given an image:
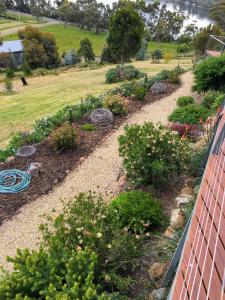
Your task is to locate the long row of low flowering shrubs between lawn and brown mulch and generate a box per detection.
[0,68,183,162]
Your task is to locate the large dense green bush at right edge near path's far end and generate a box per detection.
[193,55,225,92]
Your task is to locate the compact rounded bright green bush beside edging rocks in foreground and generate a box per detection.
[111,191,165,234]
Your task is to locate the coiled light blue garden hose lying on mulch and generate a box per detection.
[0,169,31,194]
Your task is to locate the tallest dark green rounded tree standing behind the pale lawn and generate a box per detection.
[107,7,144,62]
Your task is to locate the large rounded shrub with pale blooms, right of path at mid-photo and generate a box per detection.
[119,123,189,189]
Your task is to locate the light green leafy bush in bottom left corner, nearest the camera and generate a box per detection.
[0,247,110,300]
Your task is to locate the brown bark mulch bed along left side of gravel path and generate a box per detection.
[0,83,179,224]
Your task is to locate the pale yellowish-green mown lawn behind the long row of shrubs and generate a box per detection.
[0,59,191,146]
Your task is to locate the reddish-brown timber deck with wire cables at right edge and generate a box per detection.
[169,102,225,300]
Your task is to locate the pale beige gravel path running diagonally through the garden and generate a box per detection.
[0,72,193,266]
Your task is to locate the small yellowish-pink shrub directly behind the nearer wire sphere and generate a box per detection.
[103,95,127,115]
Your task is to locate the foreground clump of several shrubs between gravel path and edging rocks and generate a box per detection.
[0,191,167,300]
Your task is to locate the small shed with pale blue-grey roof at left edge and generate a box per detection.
[0,40,23,67]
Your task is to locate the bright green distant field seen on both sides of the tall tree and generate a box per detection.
[4,25,177,56]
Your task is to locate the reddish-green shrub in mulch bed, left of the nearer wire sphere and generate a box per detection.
[50,122,78,152]
